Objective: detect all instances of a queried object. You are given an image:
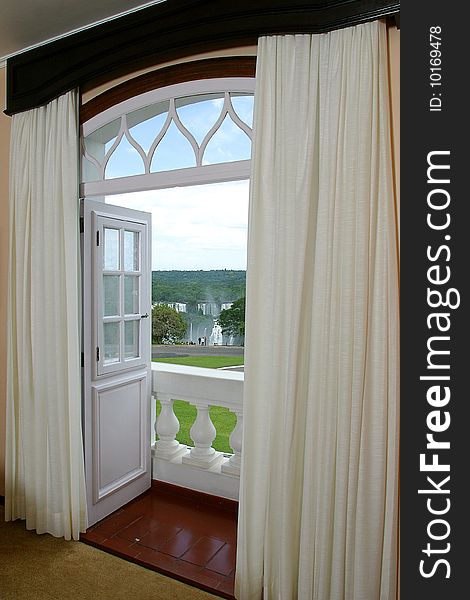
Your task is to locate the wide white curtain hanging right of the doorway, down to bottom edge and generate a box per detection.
[236,22,398,600]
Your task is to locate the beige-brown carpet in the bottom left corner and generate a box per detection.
[0,506,217,600]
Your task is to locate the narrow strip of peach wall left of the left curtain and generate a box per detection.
[0,68,11,496]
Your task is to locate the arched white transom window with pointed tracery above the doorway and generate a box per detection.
[82,78,254,196]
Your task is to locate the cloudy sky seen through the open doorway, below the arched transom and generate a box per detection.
[106,181,249,271]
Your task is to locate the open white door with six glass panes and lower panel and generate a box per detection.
[83,200,151,525]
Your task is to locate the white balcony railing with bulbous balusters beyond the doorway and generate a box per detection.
[151,363,244,499]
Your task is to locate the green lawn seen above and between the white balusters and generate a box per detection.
[153,356,243,453]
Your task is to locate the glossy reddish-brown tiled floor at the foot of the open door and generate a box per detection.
[80,482,237,599]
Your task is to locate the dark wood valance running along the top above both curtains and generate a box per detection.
[5,0,400,114]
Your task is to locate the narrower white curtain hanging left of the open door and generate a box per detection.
[5,92,86,539]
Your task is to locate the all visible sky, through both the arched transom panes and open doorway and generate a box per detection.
[89,94,253,270]
